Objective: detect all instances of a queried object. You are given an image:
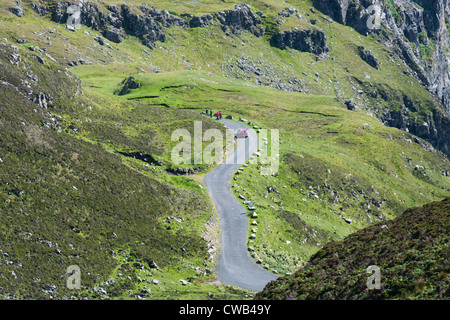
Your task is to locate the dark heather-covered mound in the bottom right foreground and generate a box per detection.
[256,198,450,300]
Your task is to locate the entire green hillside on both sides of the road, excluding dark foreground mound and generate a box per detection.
[0,0,450,299]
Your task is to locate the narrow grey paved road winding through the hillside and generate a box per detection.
[204,120,277,291]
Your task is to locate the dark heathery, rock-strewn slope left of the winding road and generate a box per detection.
[0,15,239,299]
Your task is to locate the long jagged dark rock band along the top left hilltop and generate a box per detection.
[32,1,264,49]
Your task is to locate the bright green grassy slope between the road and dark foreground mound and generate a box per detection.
[106,71,450,273]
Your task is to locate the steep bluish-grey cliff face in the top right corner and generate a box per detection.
[313,0,450,115]
